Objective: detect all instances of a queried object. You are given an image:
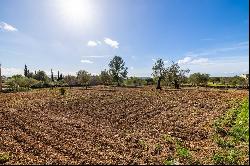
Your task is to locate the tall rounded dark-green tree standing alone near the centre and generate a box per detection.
[109,56,128,86]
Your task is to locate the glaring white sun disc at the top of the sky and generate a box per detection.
[59,0,95,24]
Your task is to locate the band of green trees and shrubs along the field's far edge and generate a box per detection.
[0,56,249,91]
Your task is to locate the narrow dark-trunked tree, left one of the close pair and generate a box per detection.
[152,59,165,89]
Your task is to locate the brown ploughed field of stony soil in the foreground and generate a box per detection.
[0,87,248,164]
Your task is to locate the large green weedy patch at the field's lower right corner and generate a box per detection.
[213,99,249,165]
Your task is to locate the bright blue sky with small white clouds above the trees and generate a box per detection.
[0,0,249,76]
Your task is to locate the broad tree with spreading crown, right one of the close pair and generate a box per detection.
[165,62,190,89]
